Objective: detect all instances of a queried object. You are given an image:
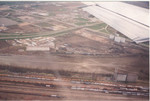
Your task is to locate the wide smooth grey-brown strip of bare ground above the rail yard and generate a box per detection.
[0,54,148,82]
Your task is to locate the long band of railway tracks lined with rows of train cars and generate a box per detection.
[0,75,149,96]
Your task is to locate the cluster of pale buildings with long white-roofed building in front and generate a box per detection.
[12,37,55,51]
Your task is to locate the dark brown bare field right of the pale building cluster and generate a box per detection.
[56,31,148,56]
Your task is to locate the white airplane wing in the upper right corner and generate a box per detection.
[83,2,149,43]
